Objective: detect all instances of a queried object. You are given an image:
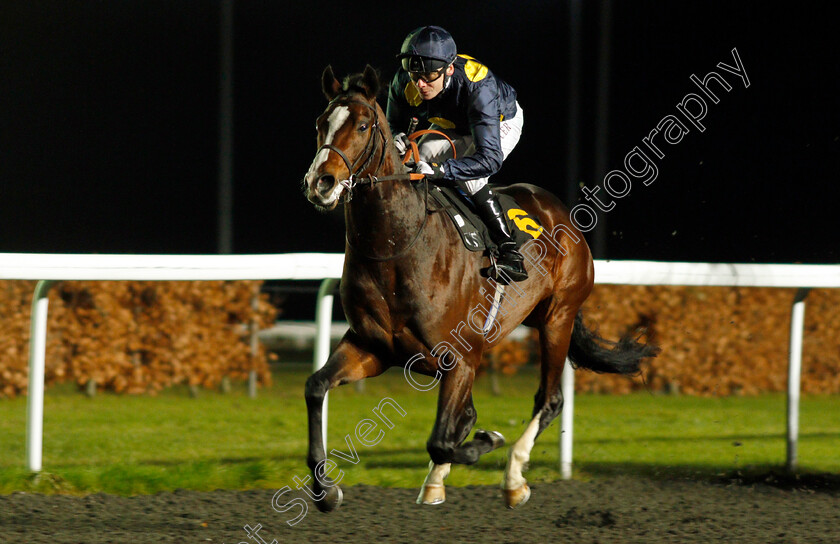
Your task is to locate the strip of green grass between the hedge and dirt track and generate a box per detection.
[0,365,840,495]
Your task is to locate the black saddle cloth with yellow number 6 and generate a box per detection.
[429,185,543,251]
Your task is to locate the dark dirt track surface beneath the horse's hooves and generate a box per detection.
[0,477,840,544]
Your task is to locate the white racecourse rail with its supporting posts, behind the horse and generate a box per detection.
[0,253,840,478]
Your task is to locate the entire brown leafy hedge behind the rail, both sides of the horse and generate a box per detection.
[6,281,840,396]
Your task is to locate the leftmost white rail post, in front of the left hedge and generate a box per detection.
[26,280,55,472]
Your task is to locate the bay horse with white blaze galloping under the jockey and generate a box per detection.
[303,65,658,512]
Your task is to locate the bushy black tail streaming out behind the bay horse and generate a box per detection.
[569,312,659,375]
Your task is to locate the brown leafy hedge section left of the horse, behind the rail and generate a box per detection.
[0,281,276,397]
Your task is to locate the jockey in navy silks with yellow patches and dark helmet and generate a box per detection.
[387,26,528,281]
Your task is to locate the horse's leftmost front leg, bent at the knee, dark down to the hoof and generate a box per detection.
[306,333,386,512]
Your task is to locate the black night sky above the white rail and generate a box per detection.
[0,0,840,263]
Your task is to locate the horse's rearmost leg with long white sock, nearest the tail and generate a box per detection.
[502,310,575,508]
